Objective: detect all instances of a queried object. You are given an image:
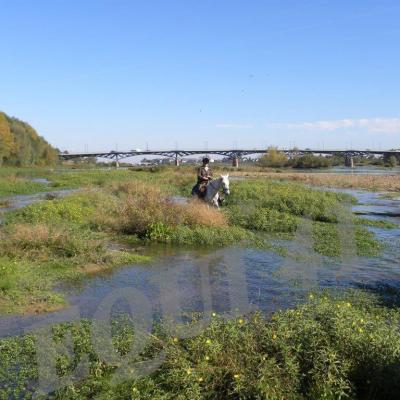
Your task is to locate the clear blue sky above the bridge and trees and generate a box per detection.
[0,0,400,151]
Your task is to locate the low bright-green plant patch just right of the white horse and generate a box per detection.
[225,179,382,257]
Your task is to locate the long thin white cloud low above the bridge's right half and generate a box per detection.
[266,118,400,134]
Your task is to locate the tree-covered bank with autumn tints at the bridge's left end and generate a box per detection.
[0,112,58,167]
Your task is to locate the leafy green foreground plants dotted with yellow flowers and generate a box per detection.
[0,291,400,400]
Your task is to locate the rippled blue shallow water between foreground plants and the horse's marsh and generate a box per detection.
[0,190,400,337]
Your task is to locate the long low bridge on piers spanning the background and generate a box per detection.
[59,149,400,167]
